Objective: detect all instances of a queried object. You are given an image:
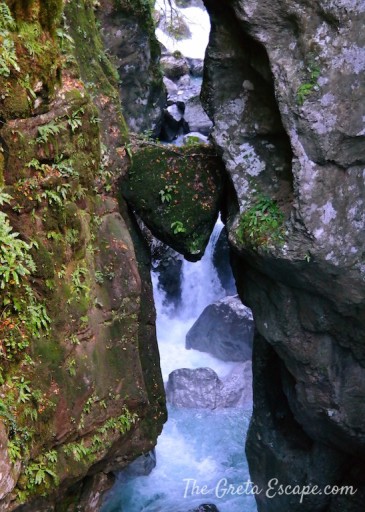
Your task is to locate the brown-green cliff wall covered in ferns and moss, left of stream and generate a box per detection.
[0,0,165,512]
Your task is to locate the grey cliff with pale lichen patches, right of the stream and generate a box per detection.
[203,0,365,512]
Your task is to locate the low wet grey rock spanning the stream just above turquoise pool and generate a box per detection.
[166,361,252,409]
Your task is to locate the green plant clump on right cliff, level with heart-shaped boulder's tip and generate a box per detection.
[237,194,284,248]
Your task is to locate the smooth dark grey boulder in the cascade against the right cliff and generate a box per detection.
[185,295,254,361]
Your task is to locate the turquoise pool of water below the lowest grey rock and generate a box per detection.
[101,408,257,512]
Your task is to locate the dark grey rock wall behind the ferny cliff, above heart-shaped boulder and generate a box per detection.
[94,0,166,136]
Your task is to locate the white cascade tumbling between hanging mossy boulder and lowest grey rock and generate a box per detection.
[152,220,236,382]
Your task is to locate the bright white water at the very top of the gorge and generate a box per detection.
[155,0,210,59]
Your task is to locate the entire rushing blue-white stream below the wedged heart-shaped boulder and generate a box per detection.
[102,222,256,512]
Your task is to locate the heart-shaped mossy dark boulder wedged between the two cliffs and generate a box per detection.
[121,144,223,261]
